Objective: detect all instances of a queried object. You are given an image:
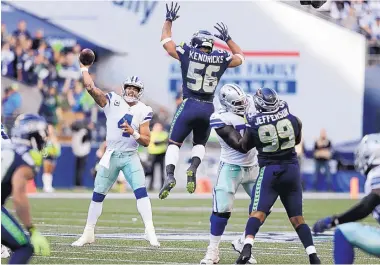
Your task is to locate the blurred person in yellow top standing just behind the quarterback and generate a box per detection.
[148,122,169,190]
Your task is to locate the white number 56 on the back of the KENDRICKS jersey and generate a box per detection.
[187,61,220,94]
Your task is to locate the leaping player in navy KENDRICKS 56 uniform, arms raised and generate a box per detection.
[159,3,244,199]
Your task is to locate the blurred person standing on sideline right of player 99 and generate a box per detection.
[314,129,332,189]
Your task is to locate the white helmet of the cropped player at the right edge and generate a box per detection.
[355,133,380,175]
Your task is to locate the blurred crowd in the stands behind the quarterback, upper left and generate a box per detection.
[1,21,169,141]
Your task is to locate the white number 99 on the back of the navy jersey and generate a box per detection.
[258,119,296,153]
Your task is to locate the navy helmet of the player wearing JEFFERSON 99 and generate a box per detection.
[253,87,280,112]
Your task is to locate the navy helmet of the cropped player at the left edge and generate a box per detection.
[12,114,48,151]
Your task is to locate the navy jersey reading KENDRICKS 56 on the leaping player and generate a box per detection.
[176,43,232,102]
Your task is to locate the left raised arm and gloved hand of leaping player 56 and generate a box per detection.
[161,2,180,60]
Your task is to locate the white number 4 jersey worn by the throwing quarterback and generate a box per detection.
[103,92,153,152]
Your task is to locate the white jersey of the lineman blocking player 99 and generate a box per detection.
[210,110,257,167]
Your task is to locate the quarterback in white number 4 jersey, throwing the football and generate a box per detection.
[72,51,160,247]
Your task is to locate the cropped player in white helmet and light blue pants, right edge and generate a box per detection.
[313,133,380,264]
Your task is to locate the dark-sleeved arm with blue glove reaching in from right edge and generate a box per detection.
[313,189,380,233]
